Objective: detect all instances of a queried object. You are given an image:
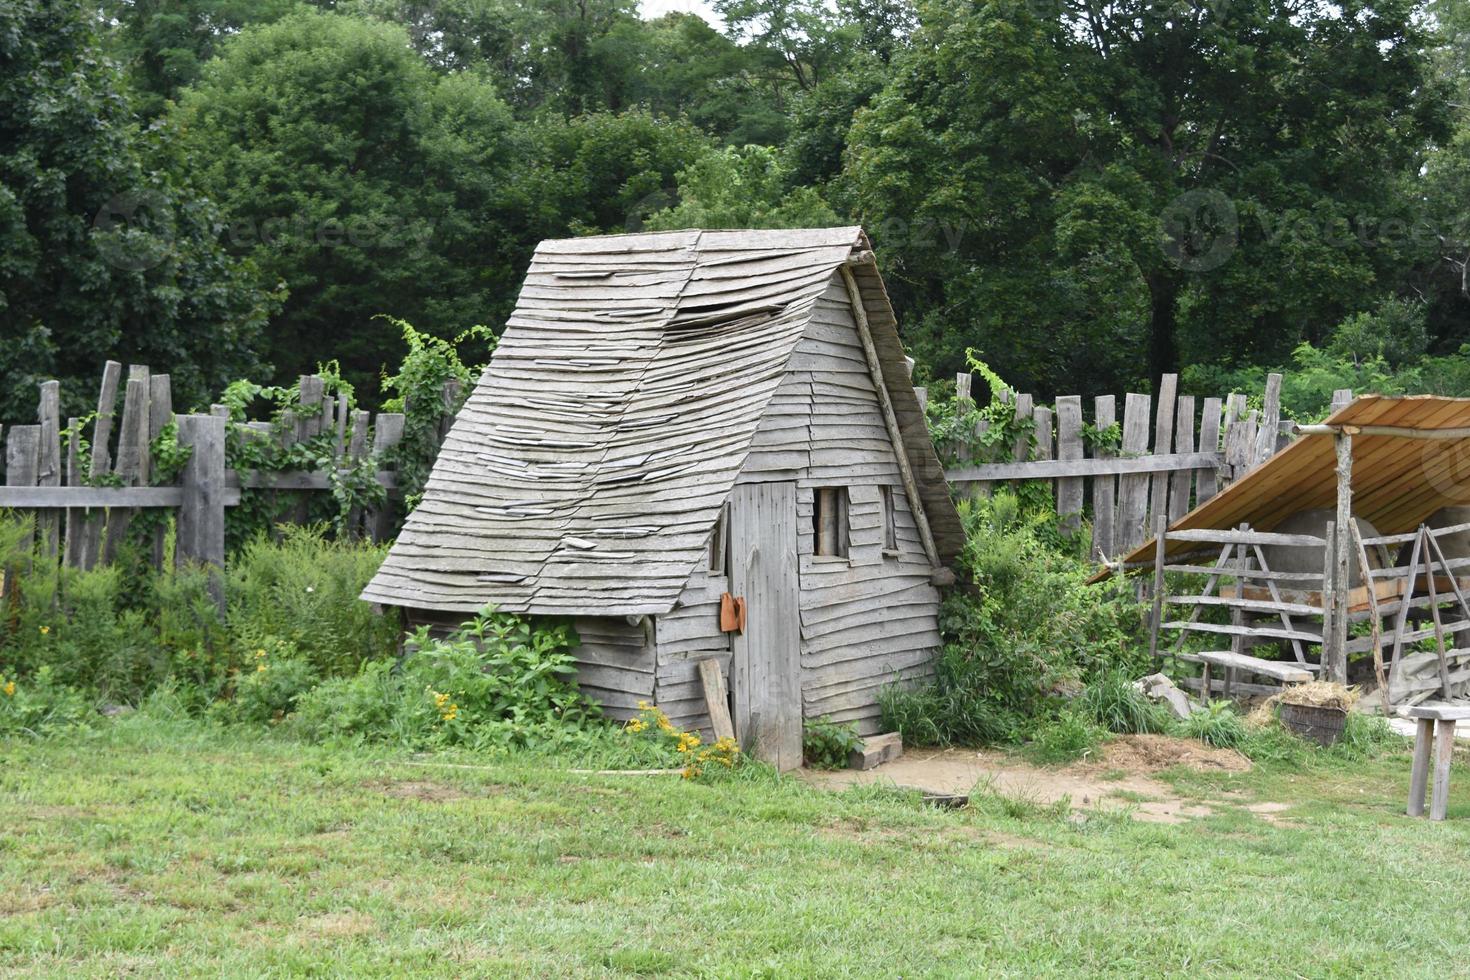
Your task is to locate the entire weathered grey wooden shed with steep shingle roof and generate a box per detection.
[363,228,963,767]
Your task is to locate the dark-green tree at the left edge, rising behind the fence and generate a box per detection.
[0,0,275,419]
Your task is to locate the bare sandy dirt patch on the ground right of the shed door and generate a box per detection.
[803,735,1251,823]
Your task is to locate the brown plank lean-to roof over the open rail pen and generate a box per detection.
[1098,395,1470,577]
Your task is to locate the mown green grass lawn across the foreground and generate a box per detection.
[0,717,1470,977]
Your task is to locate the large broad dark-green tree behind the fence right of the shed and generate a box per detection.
[845,0,1444,389]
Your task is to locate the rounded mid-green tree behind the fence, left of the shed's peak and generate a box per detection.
[173,12,525,389]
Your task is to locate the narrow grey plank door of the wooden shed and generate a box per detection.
[729,483,801,768]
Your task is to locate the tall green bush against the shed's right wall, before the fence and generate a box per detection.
[881,492,1148,745]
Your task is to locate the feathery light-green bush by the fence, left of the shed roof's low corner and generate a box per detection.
[225,525,398,677]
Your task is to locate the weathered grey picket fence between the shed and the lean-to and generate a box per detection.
[940,373,1352,560]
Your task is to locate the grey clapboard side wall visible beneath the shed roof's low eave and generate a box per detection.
[404,610,656,718]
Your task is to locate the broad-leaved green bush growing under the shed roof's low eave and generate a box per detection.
[293,611,598,748]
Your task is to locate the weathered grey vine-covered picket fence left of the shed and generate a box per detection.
[0,361,429,599]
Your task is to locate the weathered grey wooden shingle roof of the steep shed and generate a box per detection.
[363,228,963,616]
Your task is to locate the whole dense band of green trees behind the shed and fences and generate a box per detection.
[0,0,1470,414]
